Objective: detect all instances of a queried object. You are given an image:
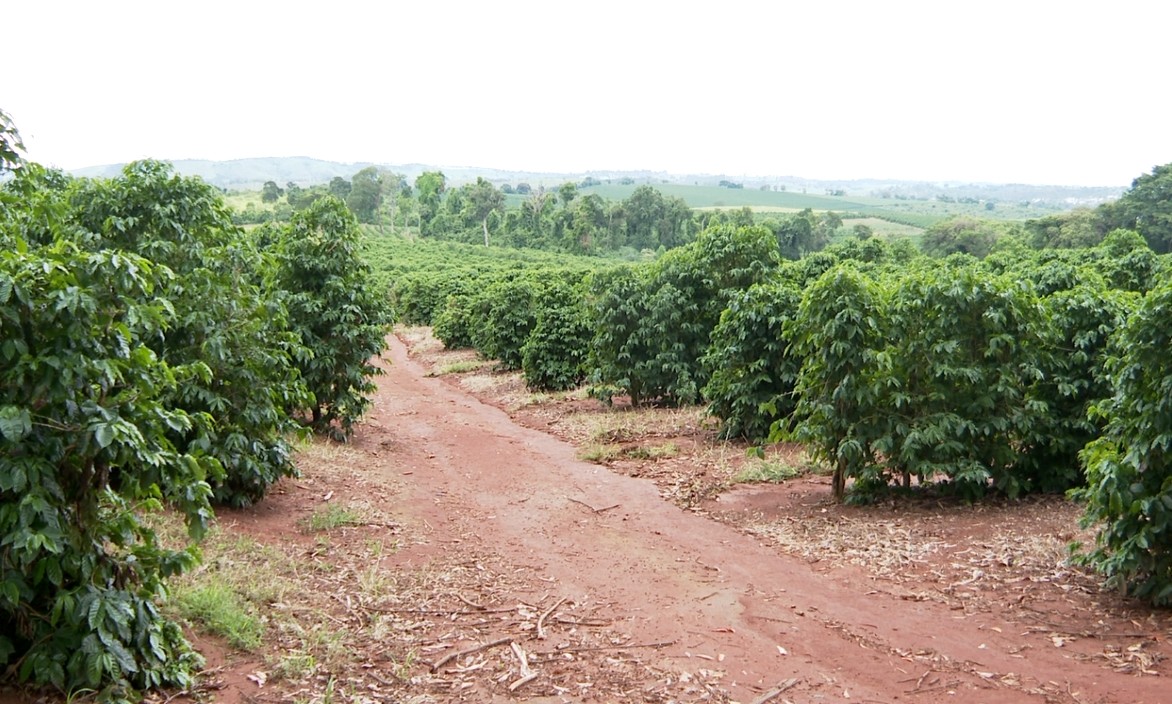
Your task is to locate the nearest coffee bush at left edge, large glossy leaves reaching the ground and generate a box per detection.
[0,216,210,700]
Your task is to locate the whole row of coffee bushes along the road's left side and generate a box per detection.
[0,162,390,700]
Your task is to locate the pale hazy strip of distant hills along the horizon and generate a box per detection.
[73,157,1125,207]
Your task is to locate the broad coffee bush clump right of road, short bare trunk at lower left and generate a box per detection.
[786,258,1073,498]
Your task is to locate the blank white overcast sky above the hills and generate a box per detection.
[9,0,1172,185]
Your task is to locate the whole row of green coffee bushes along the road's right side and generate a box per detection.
[389,221,1172,602]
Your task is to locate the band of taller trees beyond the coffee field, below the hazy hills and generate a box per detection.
[234,158,1172,259]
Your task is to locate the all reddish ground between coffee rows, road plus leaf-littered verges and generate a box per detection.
[0,329,1170,704]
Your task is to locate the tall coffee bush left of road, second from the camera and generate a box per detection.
[68,162,308,506]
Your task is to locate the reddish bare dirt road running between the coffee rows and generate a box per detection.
[342,339,1167,704]
